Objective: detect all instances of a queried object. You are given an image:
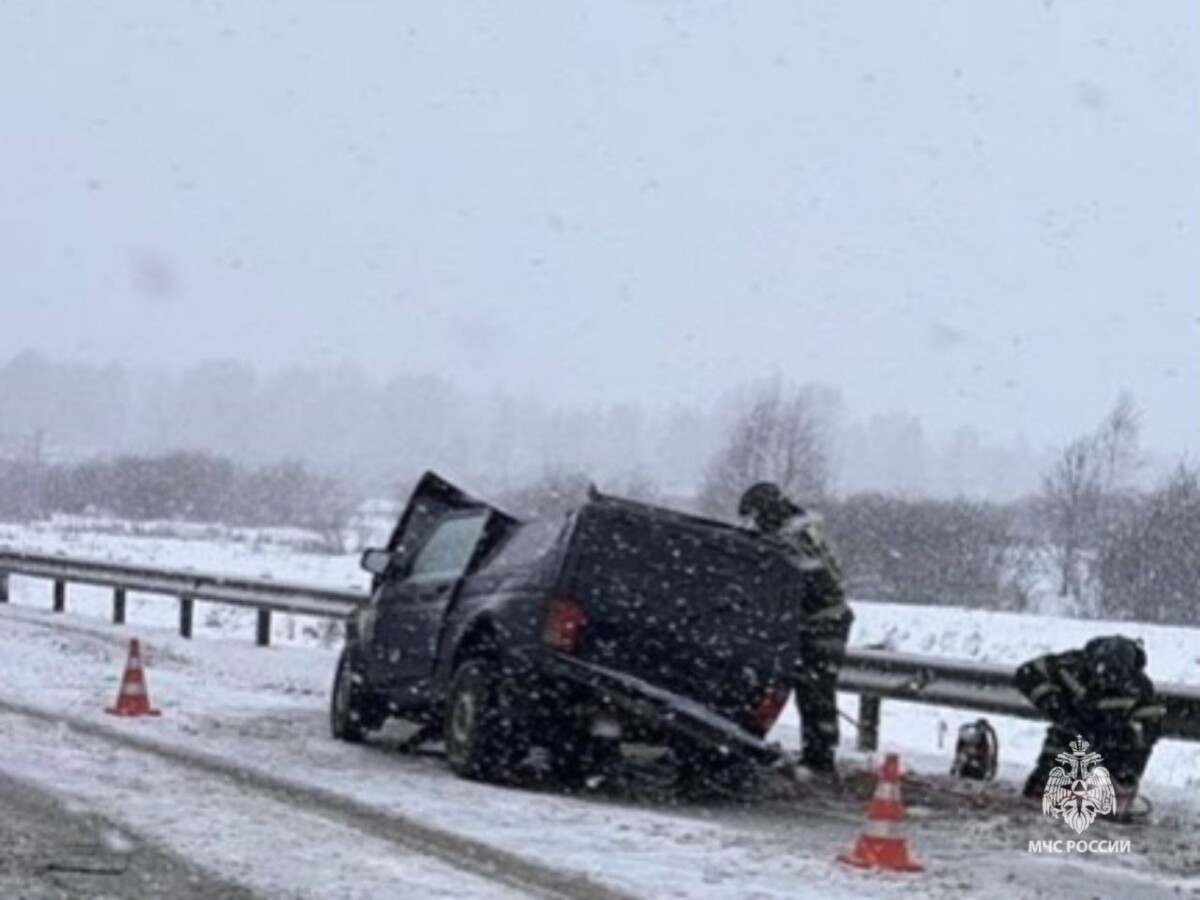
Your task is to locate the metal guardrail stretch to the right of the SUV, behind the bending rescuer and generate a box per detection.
[838,649,1200,750]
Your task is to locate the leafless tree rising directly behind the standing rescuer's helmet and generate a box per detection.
[700,380,835,517]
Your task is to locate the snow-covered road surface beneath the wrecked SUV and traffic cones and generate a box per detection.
[0,606,1196,898]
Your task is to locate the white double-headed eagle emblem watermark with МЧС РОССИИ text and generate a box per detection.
[1028,734,1130,853]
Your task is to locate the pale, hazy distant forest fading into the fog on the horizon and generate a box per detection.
[0,352,1045,497]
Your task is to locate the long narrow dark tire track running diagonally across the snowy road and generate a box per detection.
[0,697,631,900]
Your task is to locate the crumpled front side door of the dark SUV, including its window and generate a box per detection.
[366,472,517,685]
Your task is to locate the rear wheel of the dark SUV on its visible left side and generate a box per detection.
[444,659,520,781]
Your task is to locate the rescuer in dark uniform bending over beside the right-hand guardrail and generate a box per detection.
[1014,635,1166,812]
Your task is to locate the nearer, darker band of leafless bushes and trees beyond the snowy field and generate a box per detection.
[0,380,1200,624]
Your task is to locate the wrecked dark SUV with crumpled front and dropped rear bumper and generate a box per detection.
[331,473,803,780]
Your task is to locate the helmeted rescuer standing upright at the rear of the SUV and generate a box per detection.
[738,481,854,773]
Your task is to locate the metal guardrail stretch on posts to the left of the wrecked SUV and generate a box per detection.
[0,551,367,647]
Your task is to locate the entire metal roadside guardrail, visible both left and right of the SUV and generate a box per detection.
[0,551,1200,750]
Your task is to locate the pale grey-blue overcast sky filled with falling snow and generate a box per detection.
[0,0,1200,454]
